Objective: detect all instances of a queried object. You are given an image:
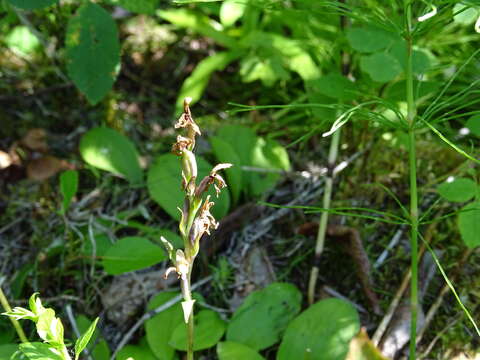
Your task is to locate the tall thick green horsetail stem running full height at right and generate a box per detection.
[404,0,418,360]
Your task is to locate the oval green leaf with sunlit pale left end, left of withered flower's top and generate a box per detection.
[80,127,143,184]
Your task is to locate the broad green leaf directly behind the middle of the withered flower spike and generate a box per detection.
[147,154,230,220]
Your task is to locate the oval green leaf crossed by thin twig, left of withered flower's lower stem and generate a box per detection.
[145,292,185,360]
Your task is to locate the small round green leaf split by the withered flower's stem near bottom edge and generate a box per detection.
[169,310,225,351]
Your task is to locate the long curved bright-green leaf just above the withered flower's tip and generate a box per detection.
[176,51,239,113]
